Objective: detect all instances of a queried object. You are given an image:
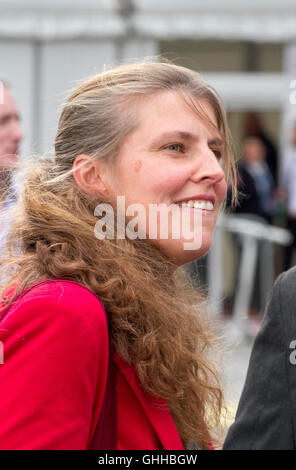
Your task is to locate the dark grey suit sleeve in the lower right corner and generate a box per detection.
[223,269,296,450]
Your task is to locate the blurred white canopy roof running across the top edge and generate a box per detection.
[0,0,296,42]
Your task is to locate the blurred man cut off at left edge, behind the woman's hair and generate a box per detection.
[0,80,23,246]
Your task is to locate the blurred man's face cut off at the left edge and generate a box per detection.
[0,87,23,168]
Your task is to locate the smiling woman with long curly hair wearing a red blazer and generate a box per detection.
[0,60,235,449]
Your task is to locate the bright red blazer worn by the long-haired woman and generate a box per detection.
[0,281,184,450]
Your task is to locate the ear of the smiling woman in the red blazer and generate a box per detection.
[73,153,107,195]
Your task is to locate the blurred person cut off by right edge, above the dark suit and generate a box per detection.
[281,125,296,270]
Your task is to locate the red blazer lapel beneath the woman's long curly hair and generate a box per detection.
[112,352,184,450]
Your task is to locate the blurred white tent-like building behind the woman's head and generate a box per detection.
[0,0,296,165]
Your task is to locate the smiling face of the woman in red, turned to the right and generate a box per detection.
[101,91,226,265]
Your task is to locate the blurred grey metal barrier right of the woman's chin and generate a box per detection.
[208,214,293,337]
